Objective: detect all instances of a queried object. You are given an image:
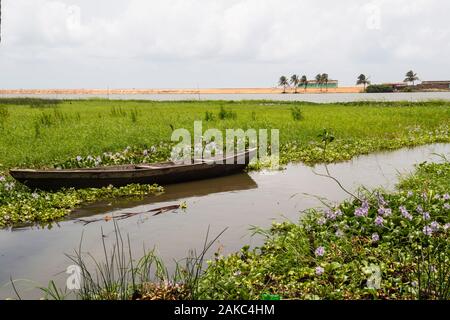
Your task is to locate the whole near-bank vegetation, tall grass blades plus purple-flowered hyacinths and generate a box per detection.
[39,160,450,300]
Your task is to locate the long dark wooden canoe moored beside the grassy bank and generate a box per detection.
[9,148,256,190]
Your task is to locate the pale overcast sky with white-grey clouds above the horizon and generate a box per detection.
[0,0,450,88]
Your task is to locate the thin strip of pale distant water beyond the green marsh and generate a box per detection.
[0,92,450,103]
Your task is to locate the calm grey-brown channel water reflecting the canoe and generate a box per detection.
[0,144,450,298]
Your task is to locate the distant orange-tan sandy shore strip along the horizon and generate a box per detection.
[0,87,363,95]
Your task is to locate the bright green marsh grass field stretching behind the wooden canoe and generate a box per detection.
[0,99,450,227]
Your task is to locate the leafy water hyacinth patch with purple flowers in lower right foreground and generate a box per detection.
[196,162,450,299]
